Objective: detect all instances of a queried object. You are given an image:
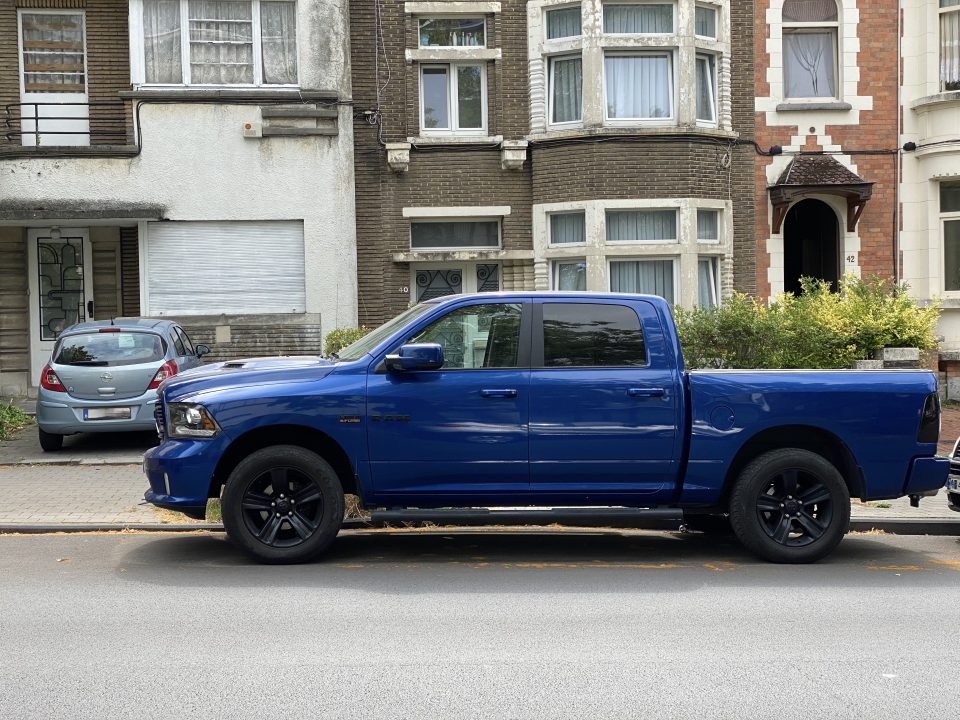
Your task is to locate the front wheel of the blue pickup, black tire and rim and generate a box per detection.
[221,445,343,564]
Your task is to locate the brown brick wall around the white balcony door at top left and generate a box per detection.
[0,0,133,145]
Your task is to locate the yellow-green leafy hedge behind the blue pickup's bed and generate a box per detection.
[675,276,939,368]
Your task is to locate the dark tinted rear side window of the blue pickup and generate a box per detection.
[543,303,647,367]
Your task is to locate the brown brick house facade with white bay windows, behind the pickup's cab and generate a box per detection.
[350,0,756,324]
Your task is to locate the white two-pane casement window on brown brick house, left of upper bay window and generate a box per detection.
[420,63,487,135]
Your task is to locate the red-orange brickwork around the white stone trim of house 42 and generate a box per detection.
[754,0,899,298]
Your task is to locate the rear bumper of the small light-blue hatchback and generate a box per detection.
[37,388,157,435]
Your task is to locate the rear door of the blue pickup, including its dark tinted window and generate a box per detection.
[530,299,682,505]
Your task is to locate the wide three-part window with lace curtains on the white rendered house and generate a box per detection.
[142,0,297,86]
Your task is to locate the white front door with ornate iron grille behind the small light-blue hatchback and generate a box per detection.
[27,228,93,382]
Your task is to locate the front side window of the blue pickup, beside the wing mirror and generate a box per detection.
[411,303,520,370]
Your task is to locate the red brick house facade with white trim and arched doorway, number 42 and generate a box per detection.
[755,0,900,297]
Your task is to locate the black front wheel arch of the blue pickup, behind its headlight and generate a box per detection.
[207,424,359,498]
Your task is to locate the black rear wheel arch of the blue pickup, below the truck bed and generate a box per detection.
[721,425,865,507]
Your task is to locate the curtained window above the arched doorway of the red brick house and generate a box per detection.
[783,0,839,98]
